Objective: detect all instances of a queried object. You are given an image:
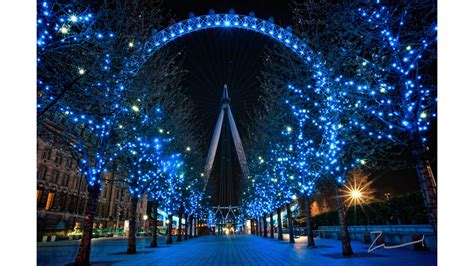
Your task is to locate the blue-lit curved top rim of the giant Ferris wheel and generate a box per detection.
[127,14,319,74]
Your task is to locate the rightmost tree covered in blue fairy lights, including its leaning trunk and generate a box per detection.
[334,2,437,231]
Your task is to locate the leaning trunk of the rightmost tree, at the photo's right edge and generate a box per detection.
[412,136,438,235]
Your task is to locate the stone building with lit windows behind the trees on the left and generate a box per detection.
[36,138,147,239]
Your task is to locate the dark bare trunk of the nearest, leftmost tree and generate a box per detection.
[74,184,100,266]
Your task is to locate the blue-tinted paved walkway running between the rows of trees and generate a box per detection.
[38,235,436,266]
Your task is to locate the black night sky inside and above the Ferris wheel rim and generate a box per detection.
[158,0,436,198]
